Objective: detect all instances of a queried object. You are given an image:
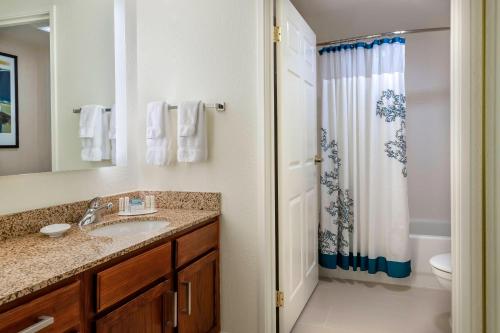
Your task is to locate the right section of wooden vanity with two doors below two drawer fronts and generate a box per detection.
[91,221,220,333]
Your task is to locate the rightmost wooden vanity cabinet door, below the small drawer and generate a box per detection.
[177,251,220,333]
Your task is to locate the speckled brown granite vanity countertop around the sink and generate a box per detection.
[0,209,220,305]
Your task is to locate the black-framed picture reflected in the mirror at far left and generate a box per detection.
[0,52,19,148]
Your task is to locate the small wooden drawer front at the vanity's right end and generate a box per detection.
[176,222,219,267]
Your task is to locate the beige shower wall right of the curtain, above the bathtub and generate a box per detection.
[406,31,451,222]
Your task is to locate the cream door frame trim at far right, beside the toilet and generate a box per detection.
[451,0,483,333]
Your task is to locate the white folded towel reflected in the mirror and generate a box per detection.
[80,105,109,162]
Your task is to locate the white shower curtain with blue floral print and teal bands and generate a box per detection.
[319,38,411,278]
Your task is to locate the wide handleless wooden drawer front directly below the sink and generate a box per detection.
[97,243,172,311]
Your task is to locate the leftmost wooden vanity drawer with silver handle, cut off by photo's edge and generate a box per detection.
[0,281,80,333]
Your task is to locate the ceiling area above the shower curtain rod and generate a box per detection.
[291,0,450,41]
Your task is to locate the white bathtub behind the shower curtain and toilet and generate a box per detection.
[320,219,451,289]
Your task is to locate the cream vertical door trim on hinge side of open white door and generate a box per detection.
[257,0,276,333]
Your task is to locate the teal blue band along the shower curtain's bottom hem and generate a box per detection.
[319,253,411,278]
